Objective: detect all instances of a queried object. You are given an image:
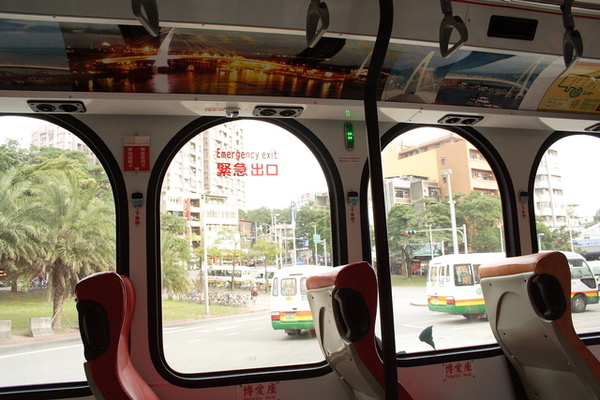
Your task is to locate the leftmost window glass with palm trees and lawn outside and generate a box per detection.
[0,117,115,387]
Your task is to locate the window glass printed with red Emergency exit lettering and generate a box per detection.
[161,121,332,373]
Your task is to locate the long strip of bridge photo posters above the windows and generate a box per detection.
[0,19,600,115]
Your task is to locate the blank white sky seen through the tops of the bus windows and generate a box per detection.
[0,116,600,217]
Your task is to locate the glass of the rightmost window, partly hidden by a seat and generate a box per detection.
[533,135,600,333]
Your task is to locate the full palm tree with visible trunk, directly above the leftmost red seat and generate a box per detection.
[32,170,115,329]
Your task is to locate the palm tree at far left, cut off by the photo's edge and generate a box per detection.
[0,169,42,291]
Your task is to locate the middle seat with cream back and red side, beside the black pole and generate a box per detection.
[306,262,412,400]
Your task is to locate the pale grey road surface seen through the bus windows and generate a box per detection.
[0,287,600,387]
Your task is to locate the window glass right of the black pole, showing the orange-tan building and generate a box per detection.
[382,128,504,353]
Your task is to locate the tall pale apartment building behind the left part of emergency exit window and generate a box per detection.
[161,123,246,256]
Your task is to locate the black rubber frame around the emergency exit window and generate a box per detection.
[146,117,348,388]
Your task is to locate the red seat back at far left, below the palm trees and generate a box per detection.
[75,272,158,400]
